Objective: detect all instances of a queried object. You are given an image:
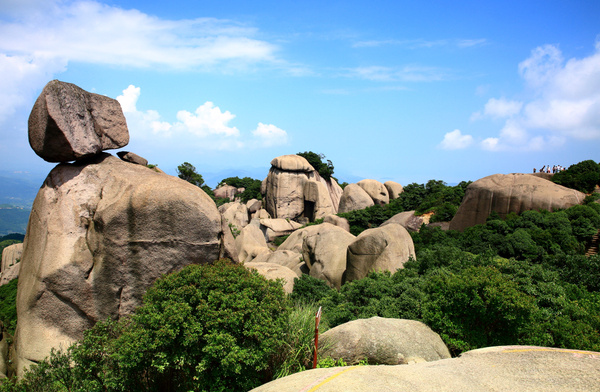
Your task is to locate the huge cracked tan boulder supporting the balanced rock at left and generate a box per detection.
[15,153,221,375]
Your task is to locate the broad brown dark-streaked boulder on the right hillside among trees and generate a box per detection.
[450,174,585,231]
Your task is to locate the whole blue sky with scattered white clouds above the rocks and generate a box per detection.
[0,0,600,185]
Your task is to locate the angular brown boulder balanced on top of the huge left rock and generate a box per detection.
[29,80,129,162]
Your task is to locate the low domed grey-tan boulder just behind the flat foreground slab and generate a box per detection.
[319,317,451,365]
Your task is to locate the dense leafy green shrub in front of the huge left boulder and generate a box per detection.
[0,261,290,391]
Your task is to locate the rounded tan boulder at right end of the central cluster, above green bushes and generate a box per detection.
[344,223,415,282]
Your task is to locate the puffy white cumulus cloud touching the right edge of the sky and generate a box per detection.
[472,41,600,151]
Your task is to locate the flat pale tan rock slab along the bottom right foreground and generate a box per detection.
[253,346,600,392]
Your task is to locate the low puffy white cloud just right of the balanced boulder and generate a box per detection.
[117,85,288,150]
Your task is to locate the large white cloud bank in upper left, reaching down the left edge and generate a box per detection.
[0,0,282,122]
